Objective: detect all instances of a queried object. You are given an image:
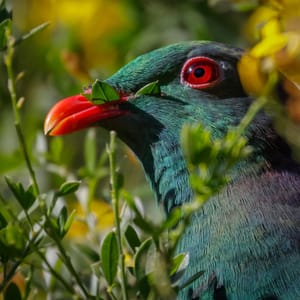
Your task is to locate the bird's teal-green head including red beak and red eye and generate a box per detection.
[45,42,272,207]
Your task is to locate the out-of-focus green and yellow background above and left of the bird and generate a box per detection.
[0,0,249,206]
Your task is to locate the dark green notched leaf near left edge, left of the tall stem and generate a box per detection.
[5,176,36,210]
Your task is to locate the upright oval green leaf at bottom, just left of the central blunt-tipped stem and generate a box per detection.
[100,231,119,285]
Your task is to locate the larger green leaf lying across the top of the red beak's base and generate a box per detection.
[90,79,120,104]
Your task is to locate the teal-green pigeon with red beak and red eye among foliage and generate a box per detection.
[44,41,300,300]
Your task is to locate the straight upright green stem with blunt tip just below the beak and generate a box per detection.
[108,131,128,300]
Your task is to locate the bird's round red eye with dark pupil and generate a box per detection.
[181,56,220,89]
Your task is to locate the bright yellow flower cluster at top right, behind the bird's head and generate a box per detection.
[238,0,300,96]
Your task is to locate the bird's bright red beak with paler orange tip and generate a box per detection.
[44,95,126,135]
